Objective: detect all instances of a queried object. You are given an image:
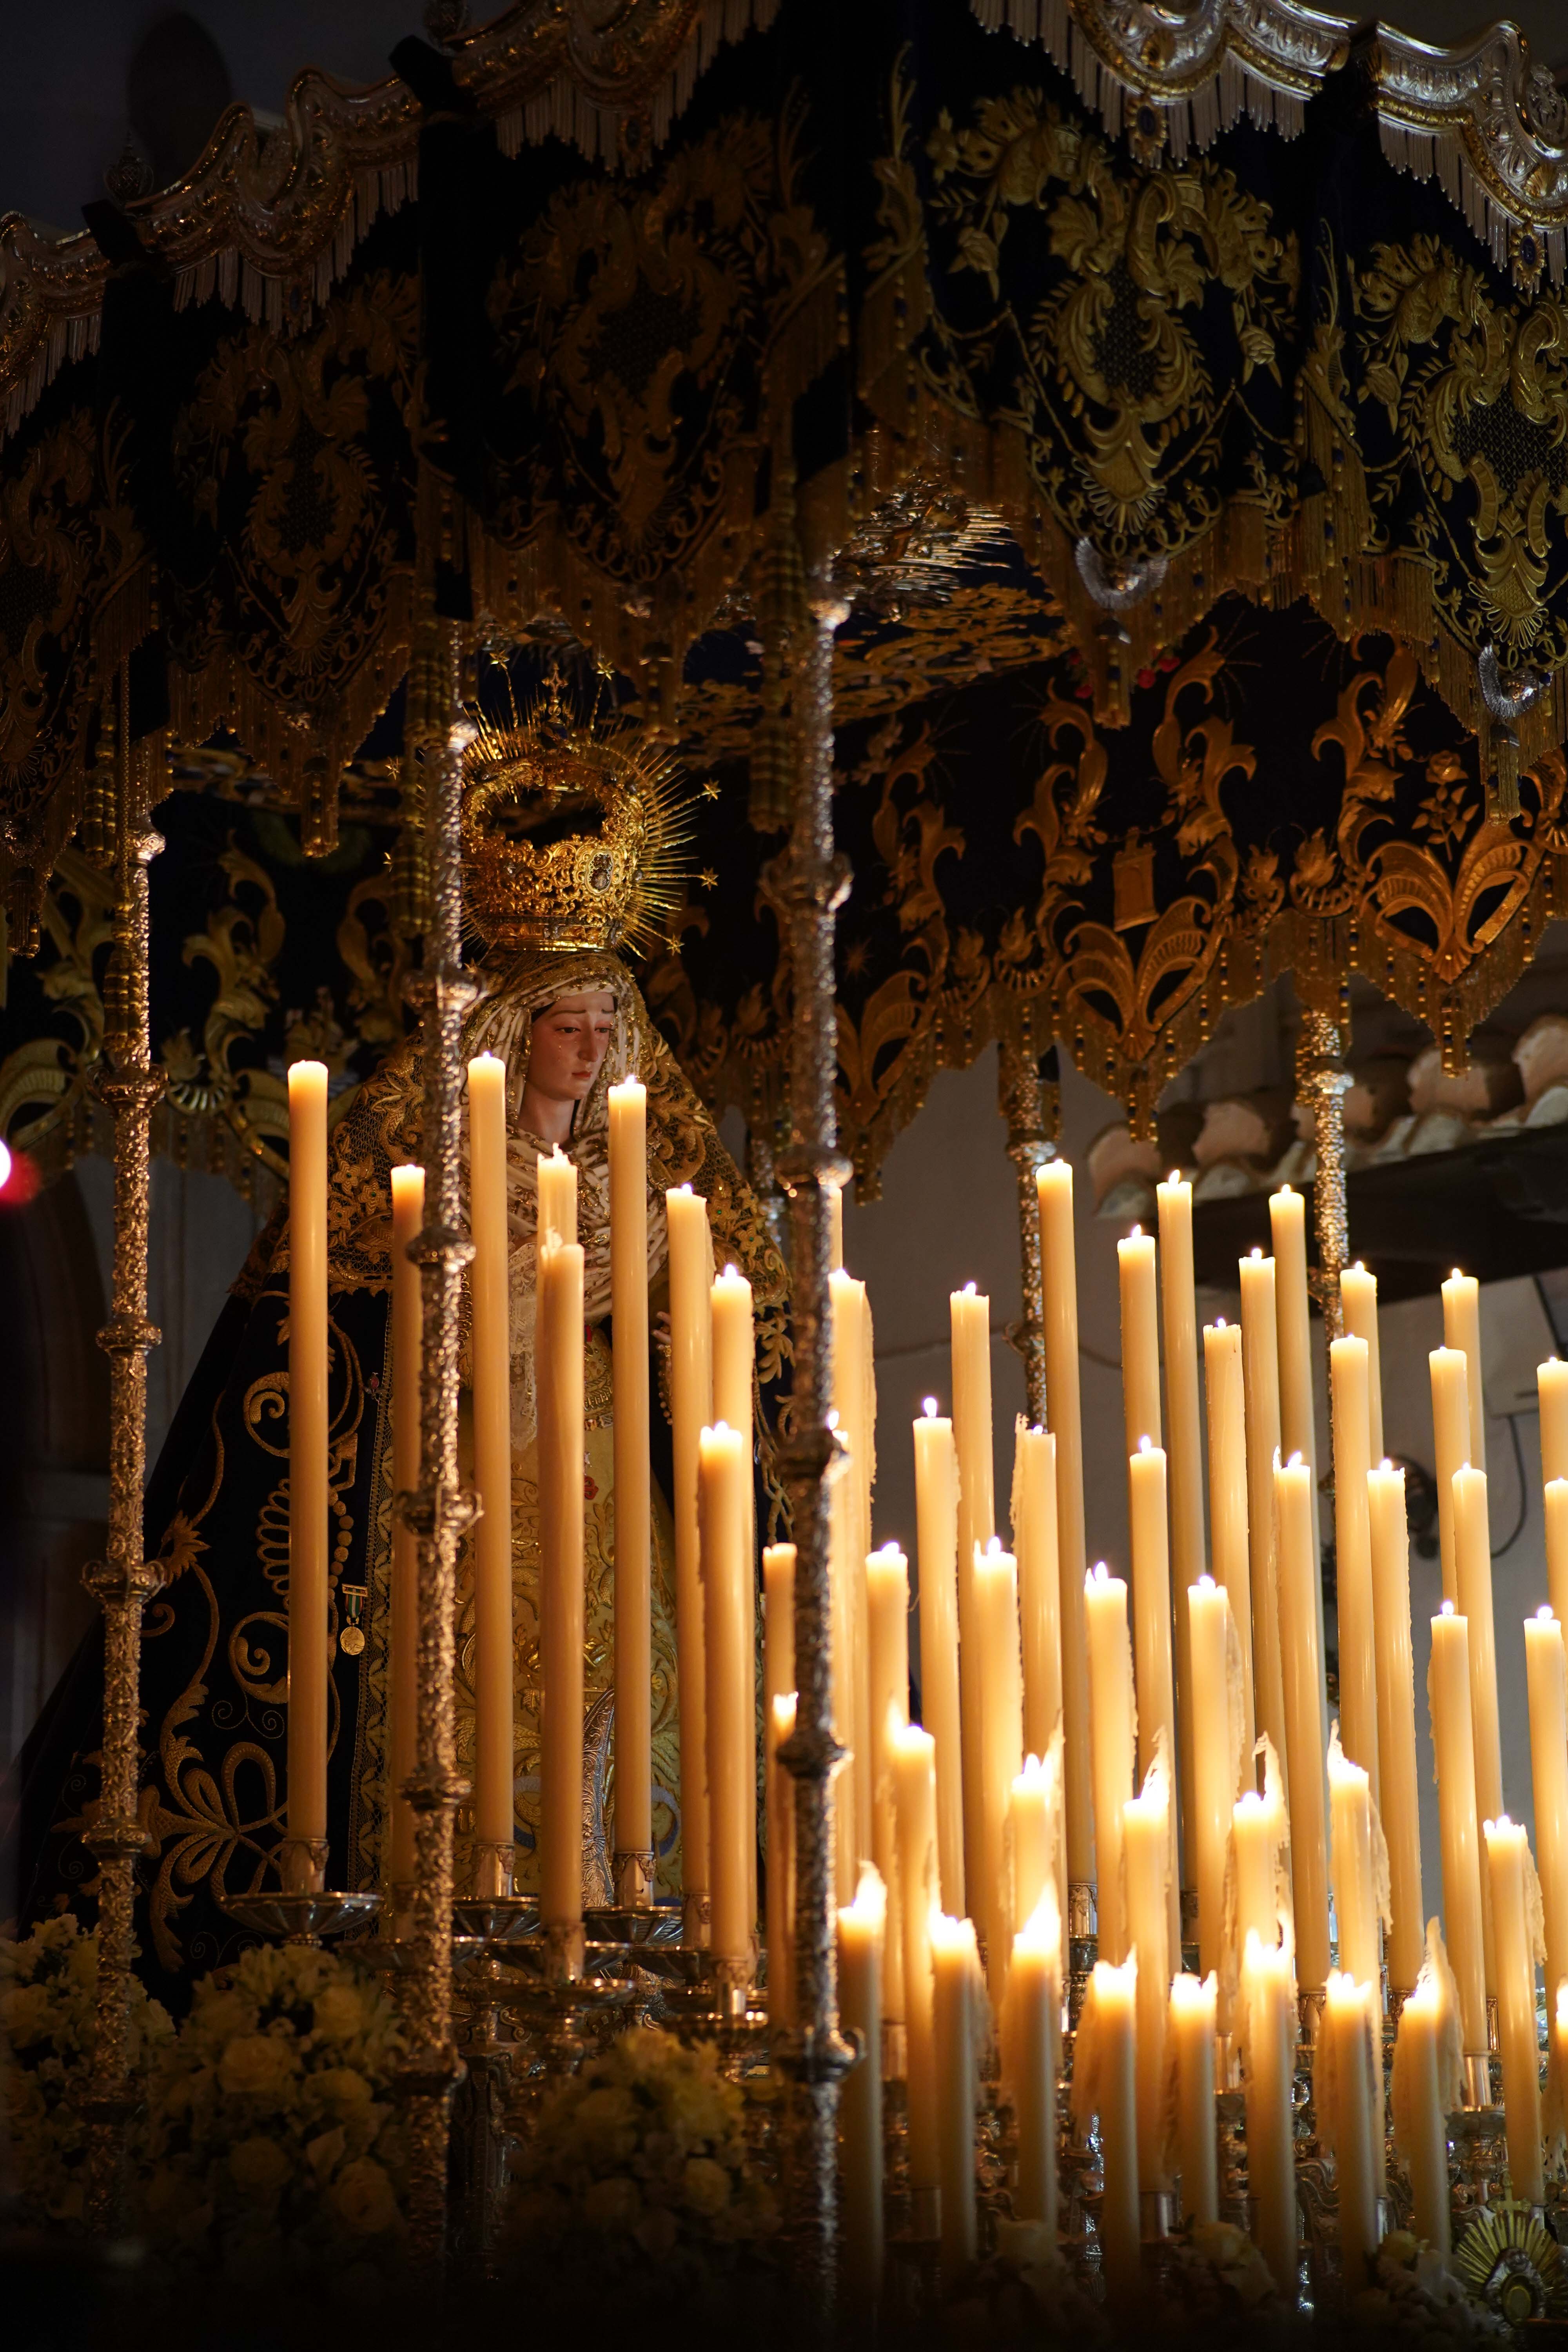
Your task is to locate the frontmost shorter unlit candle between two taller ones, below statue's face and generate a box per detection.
[534,1242,588,1929]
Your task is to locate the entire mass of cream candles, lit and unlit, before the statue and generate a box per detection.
[289,1056,1568,2296]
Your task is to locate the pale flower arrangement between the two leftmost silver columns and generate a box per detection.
[139,1945,404,2286]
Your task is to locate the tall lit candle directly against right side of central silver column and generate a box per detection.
[828,1268,877,1886]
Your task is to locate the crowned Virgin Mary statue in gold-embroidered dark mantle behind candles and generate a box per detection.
[19,710,785,1999]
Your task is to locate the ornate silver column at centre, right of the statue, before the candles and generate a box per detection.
[766,564,853,2333]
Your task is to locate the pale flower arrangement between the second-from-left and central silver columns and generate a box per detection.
[512,2027,778,2293]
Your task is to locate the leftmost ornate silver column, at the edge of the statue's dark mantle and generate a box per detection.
[82,661,162,2232]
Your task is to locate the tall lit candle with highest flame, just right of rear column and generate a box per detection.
[1034,1160,1093,1886]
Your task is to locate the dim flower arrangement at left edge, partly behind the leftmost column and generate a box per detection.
[0,1912,174,2225]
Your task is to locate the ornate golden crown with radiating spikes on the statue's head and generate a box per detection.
[463,691,691,955]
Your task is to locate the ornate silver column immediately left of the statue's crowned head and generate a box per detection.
[397,616,475,2267]
